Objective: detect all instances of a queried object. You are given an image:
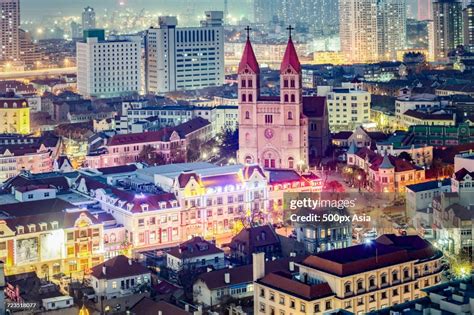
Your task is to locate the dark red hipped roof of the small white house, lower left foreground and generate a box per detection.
[91,255,151,279]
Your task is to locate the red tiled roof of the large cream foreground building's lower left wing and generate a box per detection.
[258,272,334,301]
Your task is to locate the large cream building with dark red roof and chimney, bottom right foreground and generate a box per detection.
[254,234,443,314]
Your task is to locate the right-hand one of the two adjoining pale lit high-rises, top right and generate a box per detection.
[377,0,407,60]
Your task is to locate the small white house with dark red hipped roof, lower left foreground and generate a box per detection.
[90,255,151,300]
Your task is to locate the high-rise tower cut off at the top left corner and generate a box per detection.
[0,0,20,60]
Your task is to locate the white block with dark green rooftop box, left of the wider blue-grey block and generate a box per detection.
[76,30,141,97]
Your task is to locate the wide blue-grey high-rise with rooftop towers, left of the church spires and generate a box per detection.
[145,11,224,93]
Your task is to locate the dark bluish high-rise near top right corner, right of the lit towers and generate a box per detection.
[433,0,463,60]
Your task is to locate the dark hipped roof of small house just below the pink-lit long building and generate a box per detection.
[167,236,224,259]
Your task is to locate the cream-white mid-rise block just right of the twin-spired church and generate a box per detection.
[318,86,371,131]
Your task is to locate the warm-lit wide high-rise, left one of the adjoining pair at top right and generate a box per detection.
[339,0,378,63]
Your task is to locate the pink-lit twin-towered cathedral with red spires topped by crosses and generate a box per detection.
[237,27,329,170]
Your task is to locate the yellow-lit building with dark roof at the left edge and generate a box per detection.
[0,96,30,134]
